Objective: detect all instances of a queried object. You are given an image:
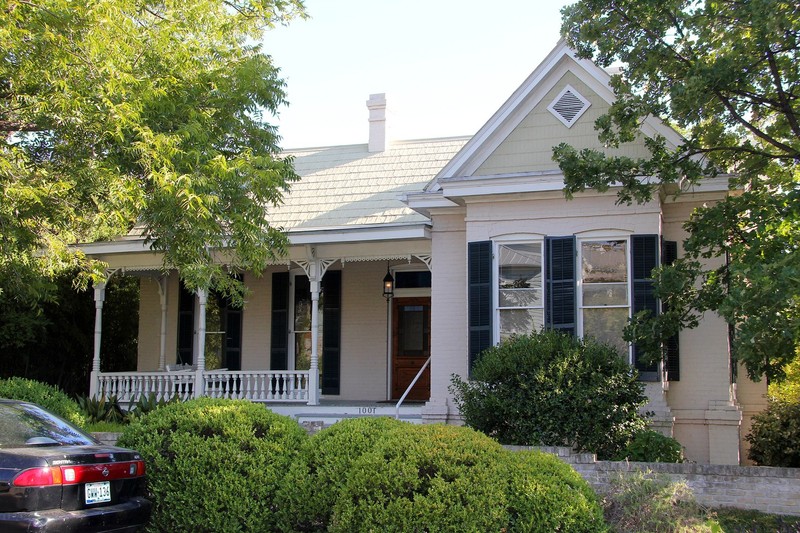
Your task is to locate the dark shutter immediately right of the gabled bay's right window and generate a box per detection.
[631,235,660,381]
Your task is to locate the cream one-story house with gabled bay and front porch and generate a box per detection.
[82,42,765,464]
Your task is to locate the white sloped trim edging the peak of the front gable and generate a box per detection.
[425,39,682,192]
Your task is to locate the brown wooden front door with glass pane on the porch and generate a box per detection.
[392,297,431,400]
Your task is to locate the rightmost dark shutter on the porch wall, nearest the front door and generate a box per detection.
[321,270,342,394]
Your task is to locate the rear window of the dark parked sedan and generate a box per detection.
[0,403,95,448]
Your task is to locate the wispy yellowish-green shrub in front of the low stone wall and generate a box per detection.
[604,472,716,533]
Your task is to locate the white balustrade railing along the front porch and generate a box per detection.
[98,370,309,407]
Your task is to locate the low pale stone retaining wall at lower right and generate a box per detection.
[508,446,800,516]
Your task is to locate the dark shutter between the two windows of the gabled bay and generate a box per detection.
[545,235,576,335]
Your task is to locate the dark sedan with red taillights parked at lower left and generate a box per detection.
[0,399,152,533]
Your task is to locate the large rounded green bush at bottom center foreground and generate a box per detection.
[278,418,605,532]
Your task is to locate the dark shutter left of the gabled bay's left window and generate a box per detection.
[467,241,492,371]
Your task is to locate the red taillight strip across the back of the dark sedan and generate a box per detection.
[11,461,145,487]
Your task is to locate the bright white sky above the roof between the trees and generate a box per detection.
[263,0,571,148]
